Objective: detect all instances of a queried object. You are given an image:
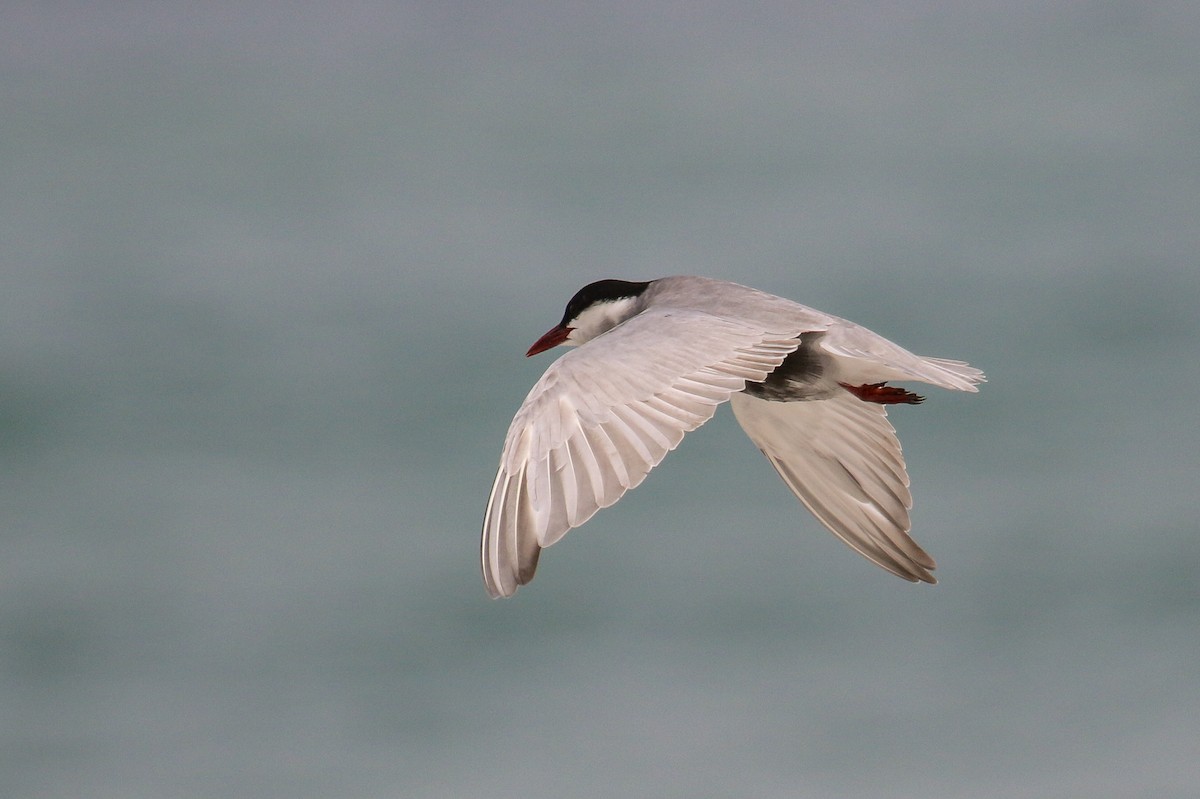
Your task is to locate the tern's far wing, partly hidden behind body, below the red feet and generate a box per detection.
[731,394,937,583]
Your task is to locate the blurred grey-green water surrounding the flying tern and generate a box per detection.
[0,0,1200,799]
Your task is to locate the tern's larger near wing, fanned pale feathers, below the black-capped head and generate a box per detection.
[481,308,803,596]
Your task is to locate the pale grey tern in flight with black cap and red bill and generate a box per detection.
[481,276,984,597]
